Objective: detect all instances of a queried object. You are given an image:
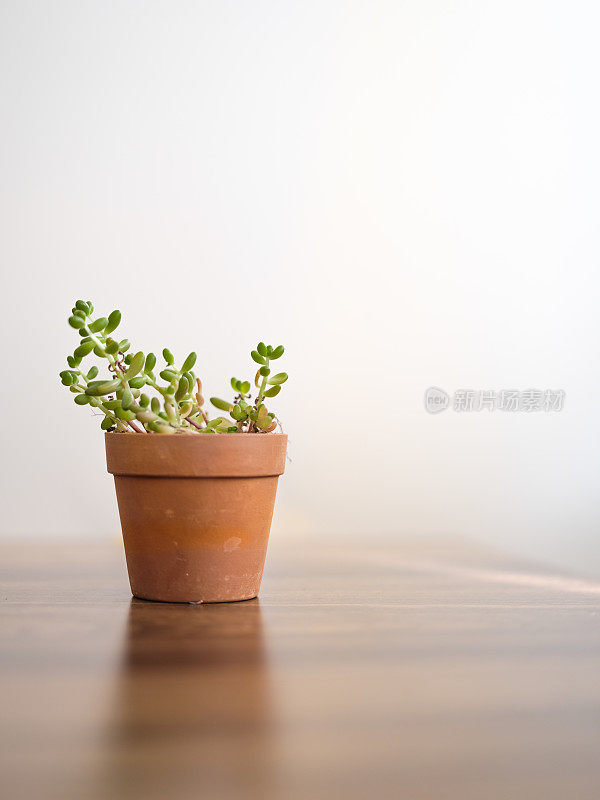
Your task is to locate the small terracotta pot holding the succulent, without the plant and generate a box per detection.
[105,433,287,603]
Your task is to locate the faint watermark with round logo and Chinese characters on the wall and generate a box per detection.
[425,386,566,414]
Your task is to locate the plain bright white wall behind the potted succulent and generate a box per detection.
[0,0,600,572]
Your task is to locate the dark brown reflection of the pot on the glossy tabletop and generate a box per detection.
[99,598,274,800]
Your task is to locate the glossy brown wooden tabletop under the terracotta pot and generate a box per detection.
[0,539,600,800]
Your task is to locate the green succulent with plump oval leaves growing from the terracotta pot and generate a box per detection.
[60,300,288,434]
